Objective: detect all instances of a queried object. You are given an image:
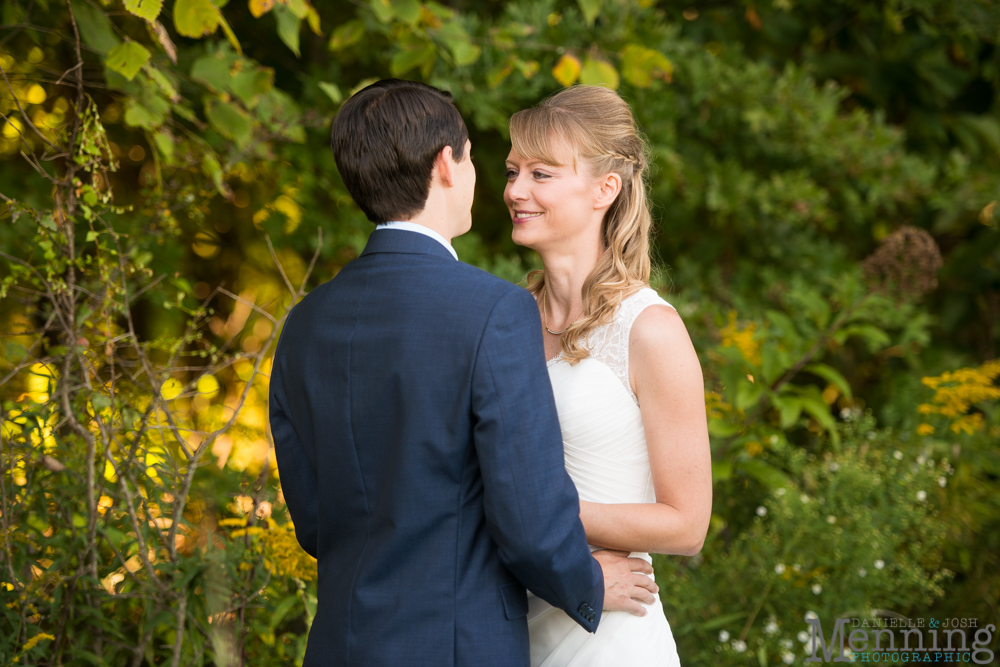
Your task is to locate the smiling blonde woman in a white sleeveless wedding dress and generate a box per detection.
[504,86,712,667]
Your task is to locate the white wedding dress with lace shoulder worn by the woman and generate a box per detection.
[528,287,680,667]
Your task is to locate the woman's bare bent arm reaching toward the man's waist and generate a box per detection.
[580,306,712,556]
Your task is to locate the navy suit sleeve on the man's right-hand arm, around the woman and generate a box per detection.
[472,289,604,632]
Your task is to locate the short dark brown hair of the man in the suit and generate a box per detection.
[330,79,469,224]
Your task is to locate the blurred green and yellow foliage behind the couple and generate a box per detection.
[0,0,1000,667]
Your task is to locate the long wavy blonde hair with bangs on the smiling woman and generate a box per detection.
[510,86,653,364]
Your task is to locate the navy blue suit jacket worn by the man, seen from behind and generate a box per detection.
[269,230,604,667]
